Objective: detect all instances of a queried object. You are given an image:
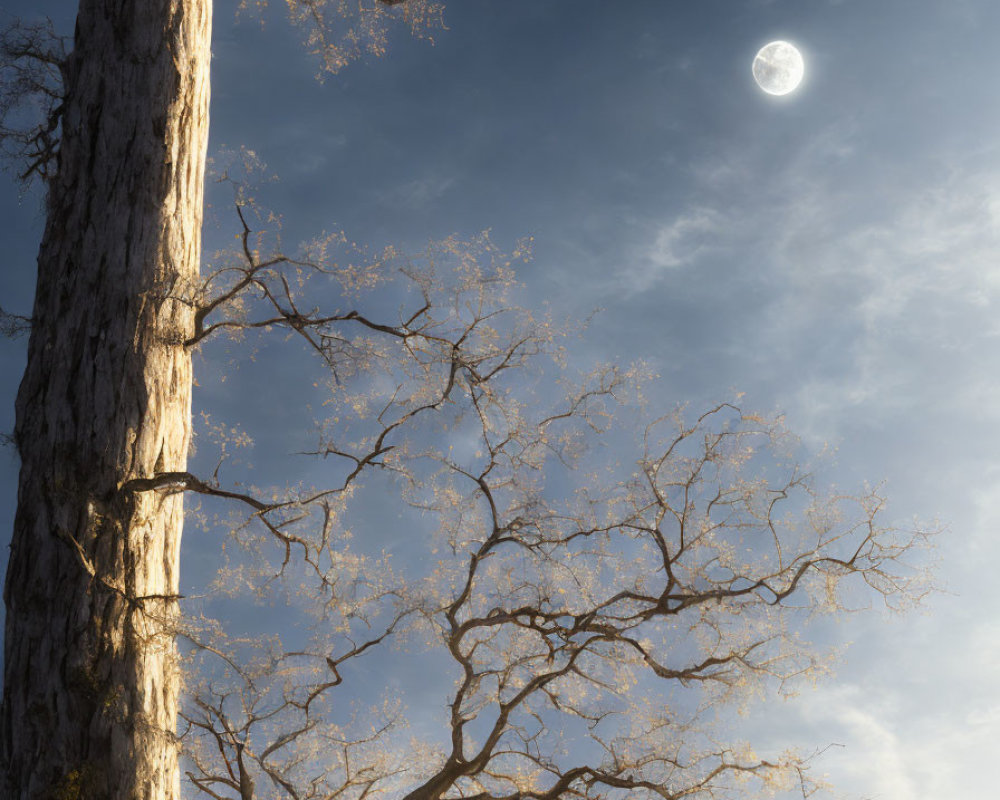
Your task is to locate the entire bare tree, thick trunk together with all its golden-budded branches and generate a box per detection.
[0,0,923,800]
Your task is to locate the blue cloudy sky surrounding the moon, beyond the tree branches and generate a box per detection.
[0,0,1000,800]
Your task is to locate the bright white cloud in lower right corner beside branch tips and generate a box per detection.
[758,592,1000,800]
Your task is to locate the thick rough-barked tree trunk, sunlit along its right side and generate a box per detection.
[0,0,211,800]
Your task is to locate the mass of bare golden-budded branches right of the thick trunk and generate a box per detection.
[146,207,927,800]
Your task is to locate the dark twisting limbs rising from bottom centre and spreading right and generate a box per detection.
[388,396,925,800]
